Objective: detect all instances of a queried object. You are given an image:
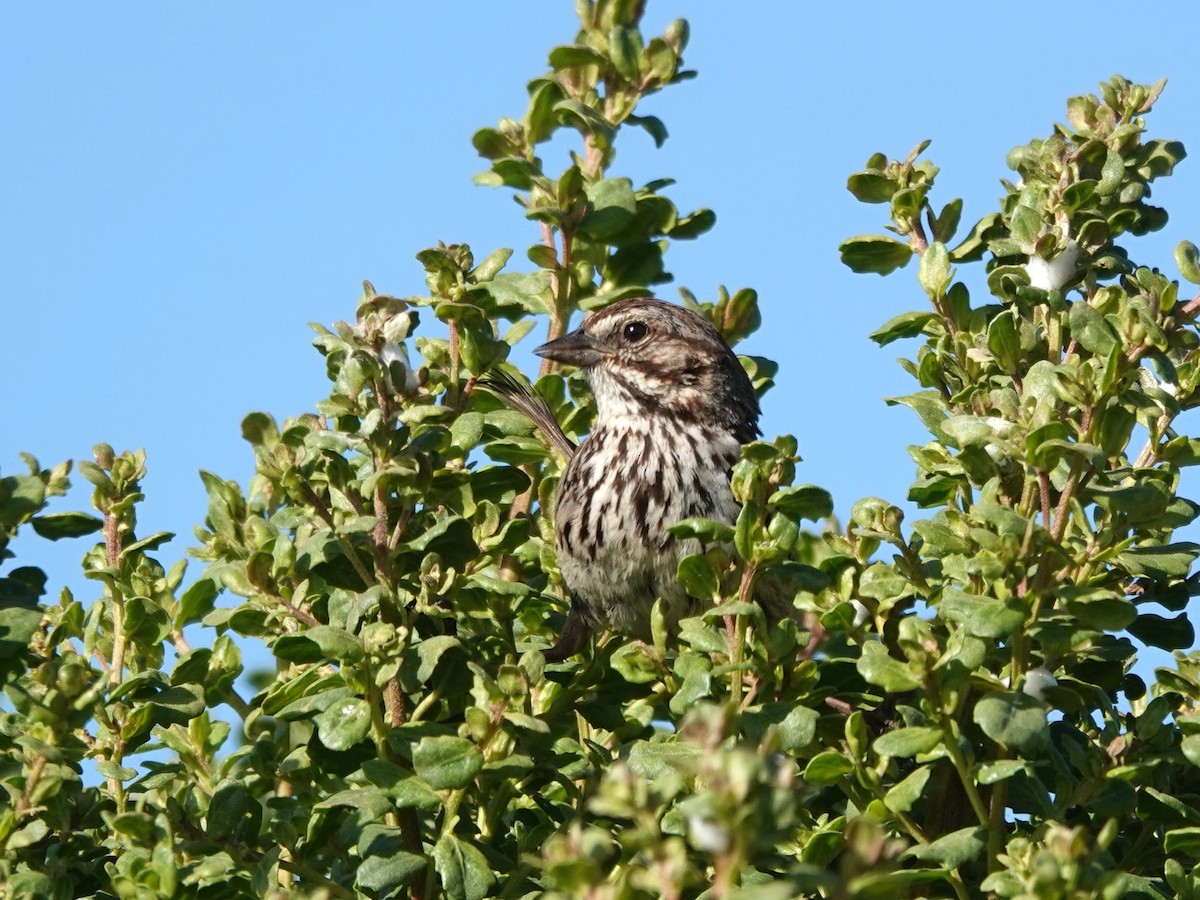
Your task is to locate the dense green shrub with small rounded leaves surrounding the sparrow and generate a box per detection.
[7,0,1200,898]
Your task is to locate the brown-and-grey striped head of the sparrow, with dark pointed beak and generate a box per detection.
[534,298,760,443]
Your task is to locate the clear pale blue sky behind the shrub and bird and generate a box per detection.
[7,0,1200,667]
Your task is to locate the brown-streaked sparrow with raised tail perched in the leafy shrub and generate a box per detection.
[490,298,777,662]
